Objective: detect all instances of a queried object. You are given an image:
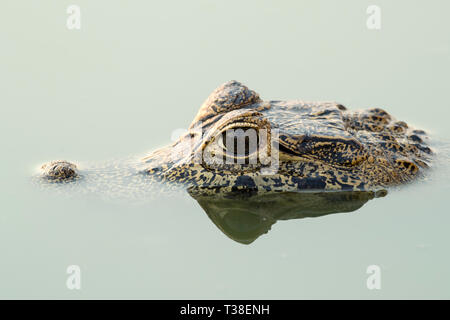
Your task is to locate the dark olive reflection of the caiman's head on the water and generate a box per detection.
[189,190,387,244]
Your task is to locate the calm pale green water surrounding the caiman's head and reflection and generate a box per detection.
[0,0,450,299]
